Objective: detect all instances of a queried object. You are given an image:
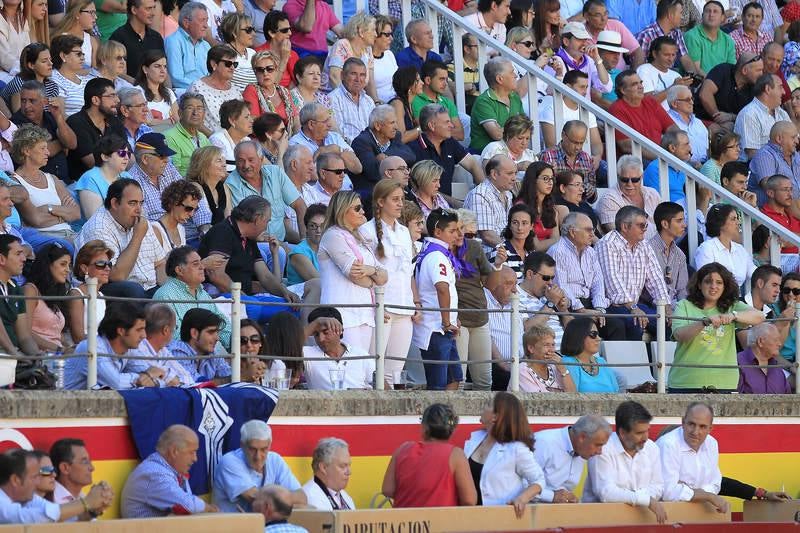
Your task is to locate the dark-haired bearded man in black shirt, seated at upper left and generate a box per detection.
[67,78,127,178]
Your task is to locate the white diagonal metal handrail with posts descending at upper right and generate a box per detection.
[412,0,800,270]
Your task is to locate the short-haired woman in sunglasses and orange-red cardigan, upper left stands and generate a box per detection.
[242,51,300,138]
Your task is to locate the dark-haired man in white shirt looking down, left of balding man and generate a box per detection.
[583,401,667,524]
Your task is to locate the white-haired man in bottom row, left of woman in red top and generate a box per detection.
[303,437,356,511]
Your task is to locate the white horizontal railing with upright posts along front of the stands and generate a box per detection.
[6,284,800,394]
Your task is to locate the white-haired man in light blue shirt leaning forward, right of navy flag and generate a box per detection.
[214,420,306,513]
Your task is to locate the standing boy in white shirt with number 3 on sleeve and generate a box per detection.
[412,208,465,390]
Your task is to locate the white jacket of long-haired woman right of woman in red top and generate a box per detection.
[464,430,545,505]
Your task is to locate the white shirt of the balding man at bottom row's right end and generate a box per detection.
[656,427,722,502]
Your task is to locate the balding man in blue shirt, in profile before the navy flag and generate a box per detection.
[120,424,217,518]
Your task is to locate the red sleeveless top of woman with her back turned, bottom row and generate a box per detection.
[394,442,458,507]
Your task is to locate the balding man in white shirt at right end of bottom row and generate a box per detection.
[656,402,730,514]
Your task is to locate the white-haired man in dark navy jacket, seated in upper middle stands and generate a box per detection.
[352,104,417,196]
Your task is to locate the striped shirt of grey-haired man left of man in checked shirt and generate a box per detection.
[547,237,608,310]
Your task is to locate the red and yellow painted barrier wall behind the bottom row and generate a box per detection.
[0,416,800,518]
